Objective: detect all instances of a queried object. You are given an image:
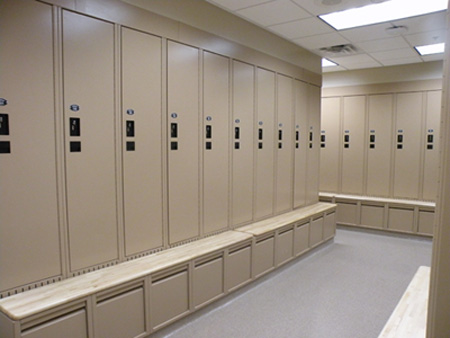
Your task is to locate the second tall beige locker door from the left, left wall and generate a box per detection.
[63,11,118,271]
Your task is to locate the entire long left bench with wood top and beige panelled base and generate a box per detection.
[0,203,336,338]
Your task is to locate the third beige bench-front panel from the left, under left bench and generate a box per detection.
[150,266,189,329]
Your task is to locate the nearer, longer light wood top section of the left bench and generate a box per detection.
[0,231,253,320]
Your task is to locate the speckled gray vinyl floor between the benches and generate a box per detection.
[151,229,432,338]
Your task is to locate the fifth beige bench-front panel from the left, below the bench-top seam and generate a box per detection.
[225,244,252,291]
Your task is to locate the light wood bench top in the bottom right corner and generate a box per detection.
[378,266,430,338]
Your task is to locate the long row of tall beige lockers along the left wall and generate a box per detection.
[0,0,320,291]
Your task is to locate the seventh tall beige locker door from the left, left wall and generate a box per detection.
[255,68,275,218]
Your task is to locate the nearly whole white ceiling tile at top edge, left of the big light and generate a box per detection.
[236,0,311,27]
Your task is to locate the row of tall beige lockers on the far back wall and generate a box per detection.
[320,91,441,201]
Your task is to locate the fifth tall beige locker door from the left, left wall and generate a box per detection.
[203,52,230,234]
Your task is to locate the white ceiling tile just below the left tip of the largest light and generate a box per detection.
[269,18,334,39]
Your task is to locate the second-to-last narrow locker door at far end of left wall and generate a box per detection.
[294,80,308,208]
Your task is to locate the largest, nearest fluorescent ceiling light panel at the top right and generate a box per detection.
[319,0,447,30]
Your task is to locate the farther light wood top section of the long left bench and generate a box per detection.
[236,202,336,236]
